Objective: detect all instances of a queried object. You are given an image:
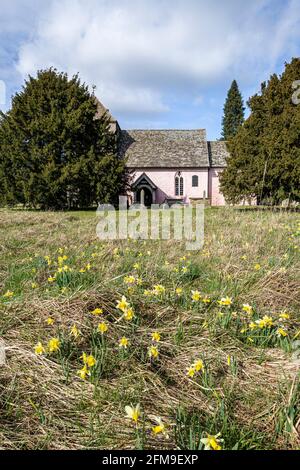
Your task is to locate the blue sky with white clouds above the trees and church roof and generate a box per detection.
[0,0,300,139]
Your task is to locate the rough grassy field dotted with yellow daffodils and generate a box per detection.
[0,208,300,450]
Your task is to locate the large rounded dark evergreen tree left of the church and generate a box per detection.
[0,69,126,209]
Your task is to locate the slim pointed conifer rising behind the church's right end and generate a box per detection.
[222,80,245,140]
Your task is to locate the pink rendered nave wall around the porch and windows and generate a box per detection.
[132,168,209,204]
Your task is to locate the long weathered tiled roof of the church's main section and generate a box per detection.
[120,129,209,168]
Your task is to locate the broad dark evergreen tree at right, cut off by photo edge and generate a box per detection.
[221,58,300,204]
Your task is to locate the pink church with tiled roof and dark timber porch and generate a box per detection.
[98,98,228,206]
